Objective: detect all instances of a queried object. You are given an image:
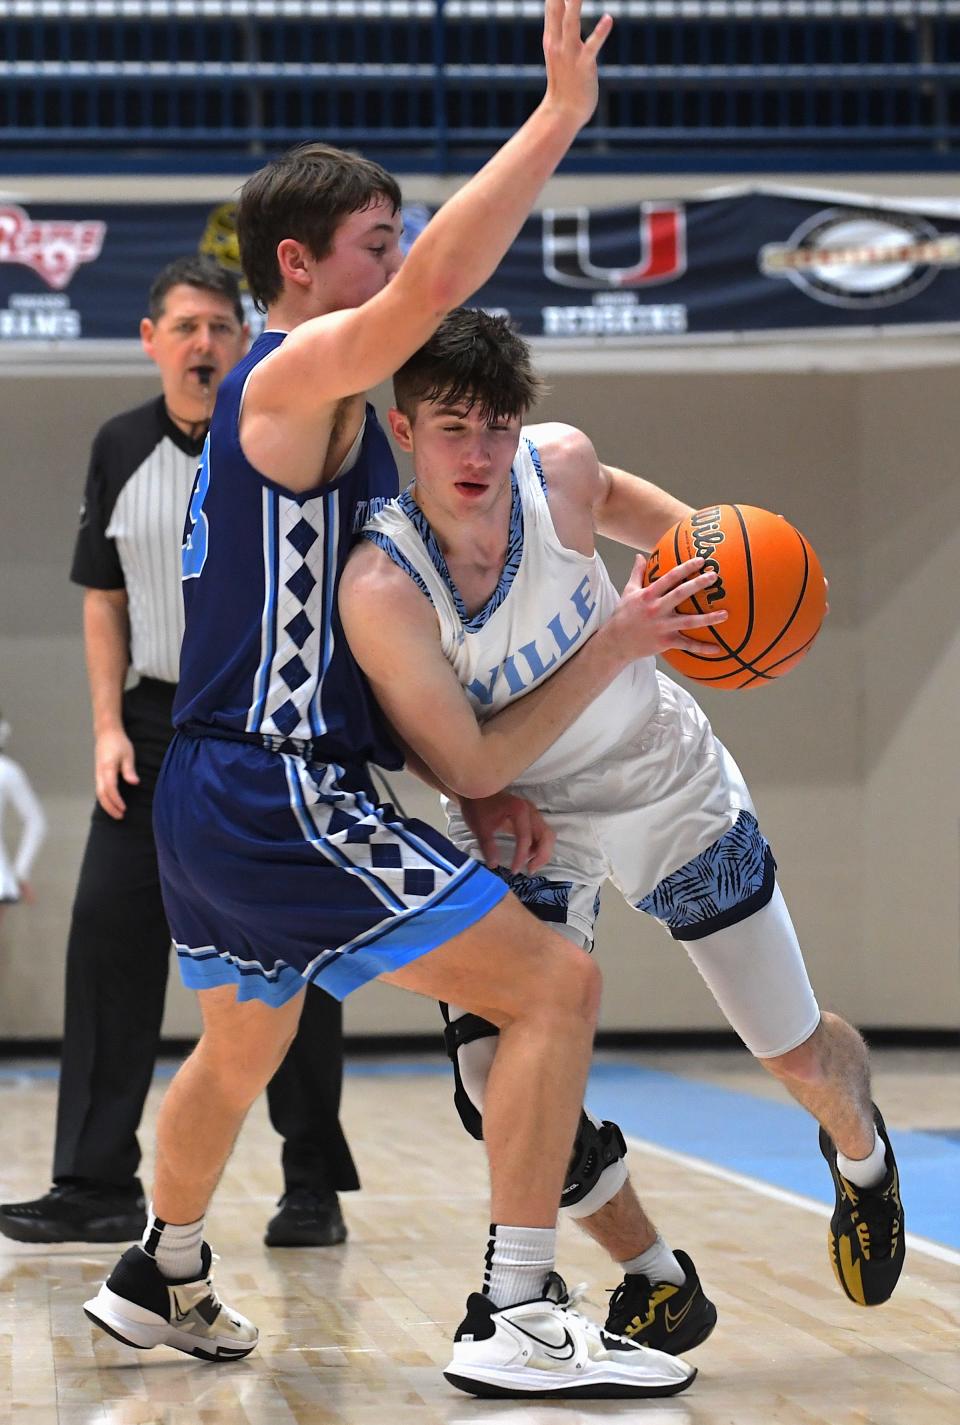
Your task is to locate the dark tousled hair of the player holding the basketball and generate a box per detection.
[393,306,541,420]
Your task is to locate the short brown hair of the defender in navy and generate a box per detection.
[236,143,400,312]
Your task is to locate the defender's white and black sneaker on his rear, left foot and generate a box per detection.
[84,1243,259,1361]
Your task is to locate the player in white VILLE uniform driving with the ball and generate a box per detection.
[340,311,903,1351]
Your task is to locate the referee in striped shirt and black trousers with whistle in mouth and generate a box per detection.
[0,257,360,1247]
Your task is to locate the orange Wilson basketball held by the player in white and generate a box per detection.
[644,504,826,688]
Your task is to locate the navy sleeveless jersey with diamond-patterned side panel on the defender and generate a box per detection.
[174,332,403,768]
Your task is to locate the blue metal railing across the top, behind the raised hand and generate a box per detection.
[0,0,960,170]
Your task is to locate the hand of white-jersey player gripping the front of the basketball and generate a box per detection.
[610,554,726,658]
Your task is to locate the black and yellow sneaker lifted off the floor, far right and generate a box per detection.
[820,1104,904,1307]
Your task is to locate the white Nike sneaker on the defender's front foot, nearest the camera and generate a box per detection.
[443,1271,696,1399]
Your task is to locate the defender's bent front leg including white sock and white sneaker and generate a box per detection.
[387,898,696,1399]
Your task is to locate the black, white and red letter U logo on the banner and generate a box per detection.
[543,202,687,291]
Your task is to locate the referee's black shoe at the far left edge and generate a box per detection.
[0,1180,147,1243]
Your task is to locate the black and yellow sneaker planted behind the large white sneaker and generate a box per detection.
[605,1251,716,1355]
